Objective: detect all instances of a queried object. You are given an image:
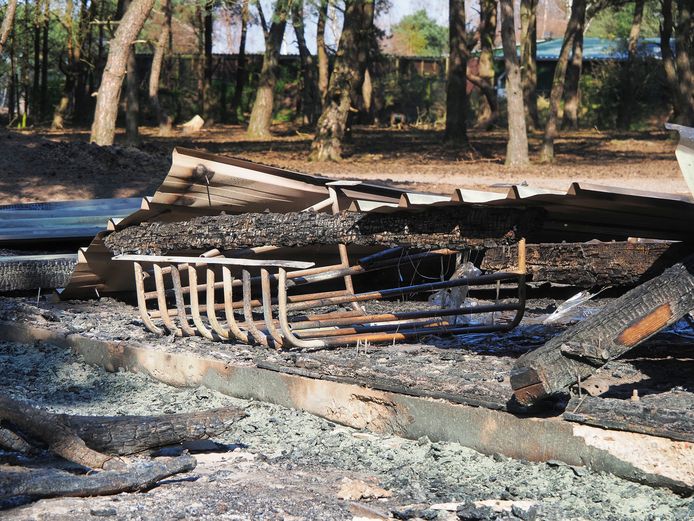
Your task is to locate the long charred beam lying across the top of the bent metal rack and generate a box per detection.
[105,206,543,254]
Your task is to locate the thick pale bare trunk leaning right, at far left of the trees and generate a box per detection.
[90,0,154,146]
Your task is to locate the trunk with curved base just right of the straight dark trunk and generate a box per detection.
[477,0,499,129]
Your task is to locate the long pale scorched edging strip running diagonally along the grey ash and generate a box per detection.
[0,322,694,494]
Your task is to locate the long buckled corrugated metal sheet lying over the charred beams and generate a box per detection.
[61,148,694,297]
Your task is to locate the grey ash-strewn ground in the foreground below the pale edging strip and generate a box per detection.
[0,342,694,520]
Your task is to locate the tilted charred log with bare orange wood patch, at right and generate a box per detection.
[511,256,694,405]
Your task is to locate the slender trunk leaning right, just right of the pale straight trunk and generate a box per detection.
[540,0,586,162]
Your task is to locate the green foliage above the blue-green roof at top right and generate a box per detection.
[586,0,660,39]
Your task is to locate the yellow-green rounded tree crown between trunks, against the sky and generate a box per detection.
[392,9,448,56]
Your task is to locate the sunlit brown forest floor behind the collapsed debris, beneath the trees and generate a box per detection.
[0,125,688,204]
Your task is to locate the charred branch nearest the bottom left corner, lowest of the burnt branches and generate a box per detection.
[0,454,197,505]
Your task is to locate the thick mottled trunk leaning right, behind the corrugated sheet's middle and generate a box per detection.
[310,0,374,161]
